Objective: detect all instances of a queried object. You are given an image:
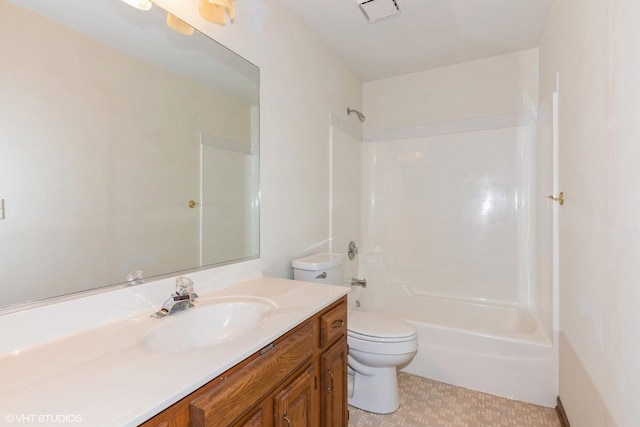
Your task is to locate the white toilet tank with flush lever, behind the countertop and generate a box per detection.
[292,253,344,285]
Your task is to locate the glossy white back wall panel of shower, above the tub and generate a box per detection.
[363,125,535,305]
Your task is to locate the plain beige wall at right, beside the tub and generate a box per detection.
[540,0,640,427]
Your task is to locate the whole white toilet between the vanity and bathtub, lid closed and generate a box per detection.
[293,253,418,414]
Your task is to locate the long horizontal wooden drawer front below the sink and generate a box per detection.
[189,323,313,426]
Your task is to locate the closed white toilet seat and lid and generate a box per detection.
[347,310,417,343]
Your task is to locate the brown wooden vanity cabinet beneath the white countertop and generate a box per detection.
[142,297,348,427]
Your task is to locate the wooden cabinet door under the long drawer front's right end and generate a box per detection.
[273,366,314,427]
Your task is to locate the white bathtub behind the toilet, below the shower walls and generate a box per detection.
[349,278,558,407]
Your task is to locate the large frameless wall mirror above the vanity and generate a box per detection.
[0,0,259,308]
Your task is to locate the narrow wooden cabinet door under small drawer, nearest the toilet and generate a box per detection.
[320,337,348,427]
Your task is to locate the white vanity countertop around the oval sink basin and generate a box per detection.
[0,277,348,427]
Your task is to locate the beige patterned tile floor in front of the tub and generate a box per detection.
[349,372,561,427]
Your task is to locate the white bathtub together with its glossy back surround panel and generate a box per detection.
[350,115,557,406]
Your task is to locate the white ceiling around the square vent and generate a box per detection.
[281,0,552,82]
